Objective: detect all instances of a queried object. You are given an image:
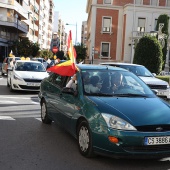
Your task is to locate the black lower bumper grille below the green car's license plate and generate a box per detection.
[123,145,170,152]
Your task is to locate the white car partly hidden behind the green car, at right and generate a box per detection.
[101,62,170,100]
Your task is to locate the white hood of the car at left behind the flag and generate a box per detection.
[14,71,49,80]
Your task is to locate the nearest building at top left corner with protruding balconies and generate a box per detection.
[0,0,29,62]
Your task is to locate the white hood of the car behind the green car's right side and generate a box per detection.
[139,76,168,85]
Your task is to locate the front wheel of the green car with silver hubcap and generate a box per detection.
[77,121,95,158]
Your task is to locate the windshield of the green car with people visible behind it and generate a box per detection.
[81,70,155,97]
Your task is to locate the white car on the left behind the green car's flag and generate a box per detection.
[7,60,49,91]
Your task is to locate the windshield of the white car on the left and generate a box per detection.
[15,62,46,72]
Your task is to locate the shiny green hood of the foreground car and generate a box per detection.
[88,96,170,126]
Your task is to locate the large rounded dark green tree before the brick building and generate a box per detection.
[133,36,163,74]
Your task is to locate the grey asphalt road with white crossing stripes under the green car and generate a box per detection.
[0,77,170,170]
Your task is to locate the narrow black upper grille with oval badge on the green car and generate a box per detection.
[135,125,170,132]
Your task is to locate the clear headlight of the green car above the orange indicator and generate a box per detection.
[102,113,136,131]
